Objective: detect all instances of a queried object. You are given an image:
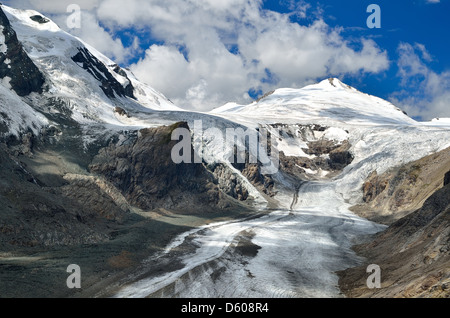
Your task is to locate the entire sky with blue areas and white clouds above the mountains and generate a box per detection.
[5,0,450,120]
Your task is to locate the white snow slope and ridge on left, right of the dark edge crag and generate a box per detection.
[1,5,182,125]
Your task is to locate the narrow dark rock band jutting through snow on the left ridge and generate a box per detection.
[72,48,136,99]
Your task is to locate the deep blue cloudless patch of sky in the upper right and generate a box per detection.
[311,0,450,100]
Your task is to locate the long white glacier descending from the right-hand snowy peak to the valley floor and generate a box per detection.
[111,92,450,298]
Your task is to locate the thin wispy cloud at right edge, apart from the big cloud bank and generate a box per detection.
[391,43,450,120]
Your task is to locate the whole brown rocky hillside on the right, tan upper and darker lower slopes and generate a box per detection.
[338,149,450,298]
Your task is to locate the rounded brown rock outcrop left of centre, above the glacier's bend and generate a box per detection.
[90,122,220,212]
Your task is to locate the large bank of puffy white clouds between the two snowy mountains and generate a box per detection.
[3,0,389,110]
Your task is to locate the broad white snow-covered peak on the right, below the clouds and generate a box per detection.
[212,78,415,125]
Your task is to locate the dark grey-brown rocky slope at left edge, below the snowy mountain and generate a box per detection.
[0,144,128,247]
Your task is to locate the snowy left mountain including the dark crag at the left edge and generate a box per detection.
[0,5,181,135]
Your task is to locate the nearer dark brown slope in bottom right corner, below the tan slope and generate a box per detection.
[340,181,450,298]
